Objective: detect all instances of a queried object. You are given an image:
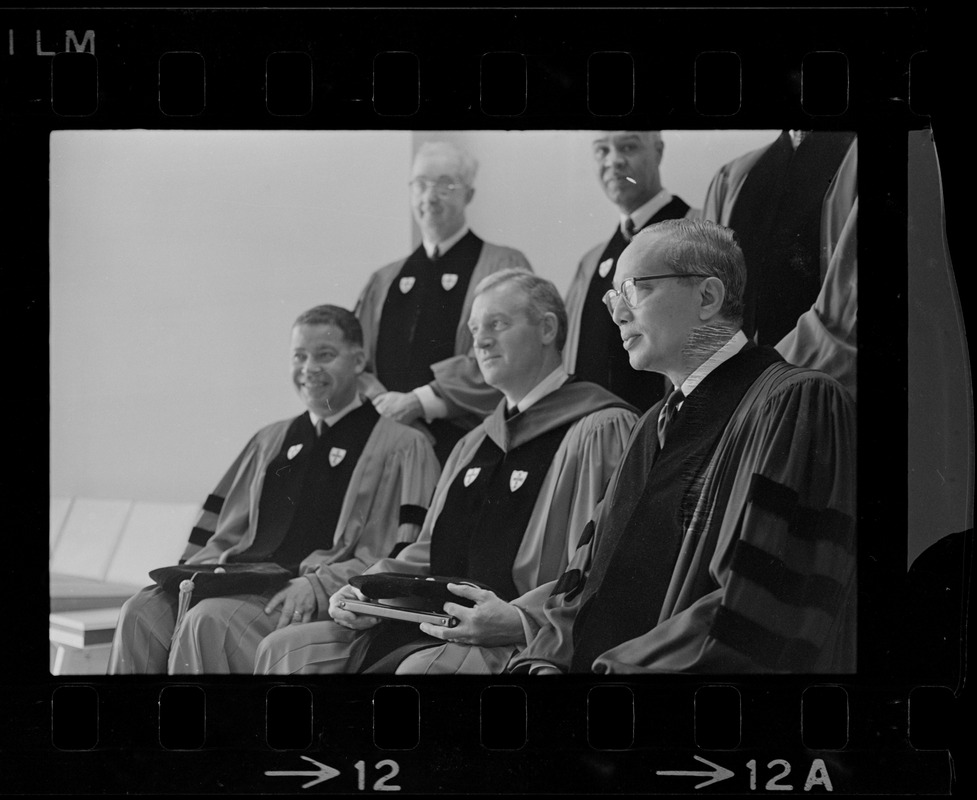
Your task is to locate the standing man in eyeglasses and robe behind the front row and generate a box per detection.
[356,142,530,464]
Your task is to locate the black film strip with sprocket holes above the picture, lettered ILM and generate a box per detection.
[0,9,934,128]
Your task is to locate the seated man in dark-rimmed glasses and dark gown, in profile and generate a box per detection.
[509,220,856,674]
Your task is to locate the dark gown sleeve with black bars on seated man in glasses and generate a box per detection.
[588,370,856,673]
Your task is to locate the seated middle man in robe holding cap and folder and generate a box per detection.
[256,270,637,674]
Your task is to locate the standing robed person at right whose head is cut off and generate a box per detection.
[702,131,858,397]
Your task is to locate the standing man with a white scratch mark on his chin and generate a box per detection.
[564,131,689,411]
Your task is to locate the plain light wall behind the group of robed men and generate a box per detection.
[49,131,777,502]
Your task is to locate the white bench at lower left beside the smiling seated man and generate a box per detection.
[49,498,200,675]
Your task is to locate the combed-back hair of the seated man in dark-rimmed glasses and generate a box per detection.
[635,219,746,323]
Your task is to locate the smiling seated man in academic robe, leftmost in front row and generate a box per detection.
[109,305,440,674]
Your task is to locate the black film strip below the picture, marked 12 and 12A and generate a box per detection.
[3,678,953,794]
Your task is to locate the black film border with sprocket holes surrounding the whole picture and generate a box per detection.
[0,3,973,794]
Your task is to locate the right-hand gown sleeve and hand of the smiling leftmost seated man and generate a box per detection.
[300,418,440,619]
